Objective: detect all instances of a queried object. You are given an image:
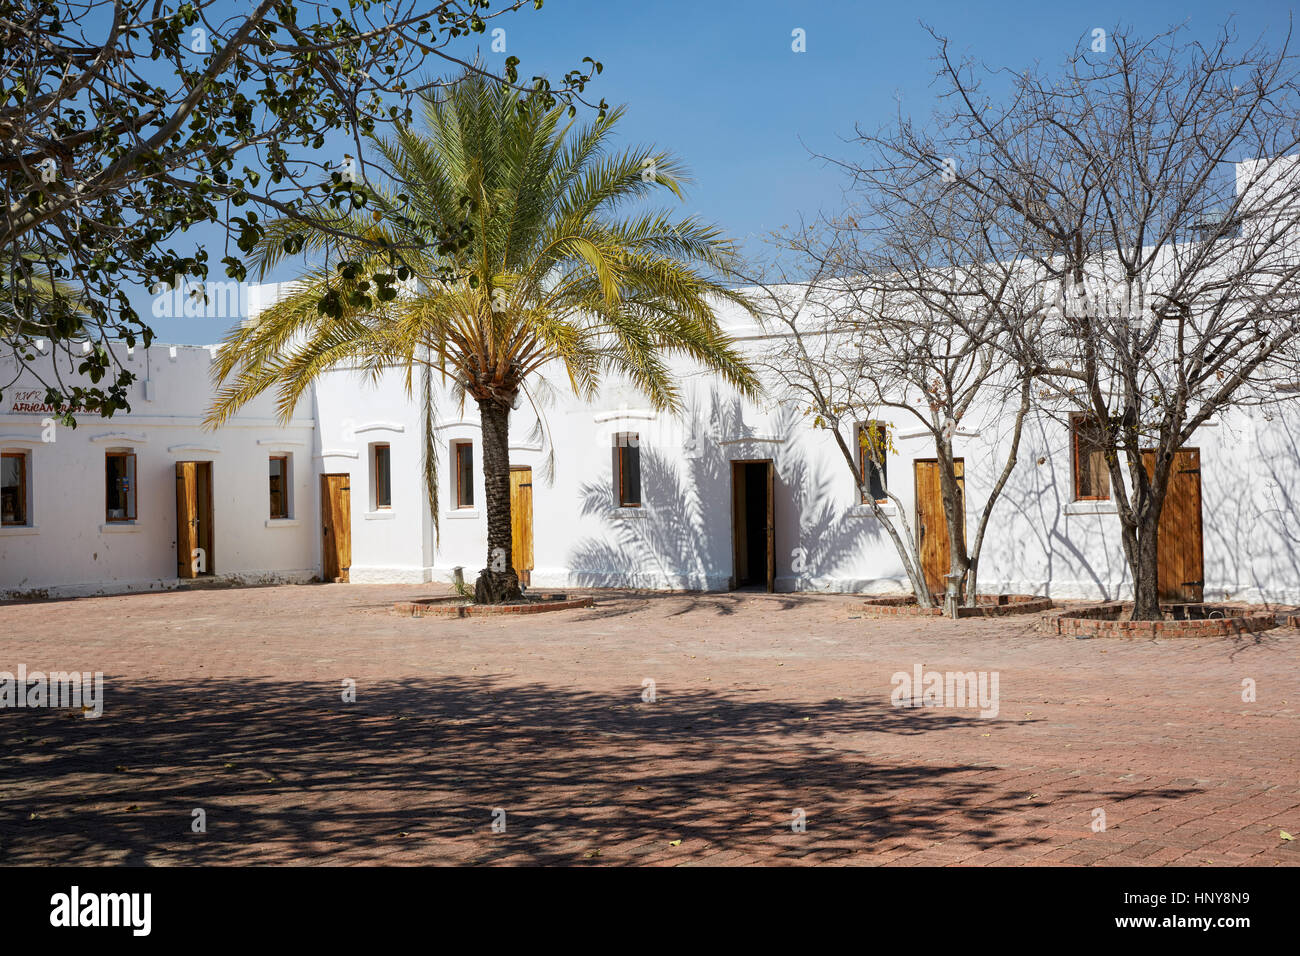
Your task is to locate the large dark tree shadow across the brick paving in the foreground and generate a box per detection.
[0,676,1184,865]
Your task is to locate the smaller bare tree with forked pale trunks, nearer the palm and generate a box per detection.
[759,165,1043,615]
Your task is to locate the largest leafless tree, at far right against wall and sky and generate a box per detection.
[883,27,1300,619]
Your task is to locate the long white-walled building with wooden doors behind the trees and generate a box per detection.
[0,297,1300,602]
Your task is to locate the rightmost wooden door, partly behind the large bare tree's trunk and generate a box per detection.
[1143,449,1205,604]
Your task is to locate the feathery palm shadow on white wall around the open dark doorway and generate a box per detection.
[568,392,889,591]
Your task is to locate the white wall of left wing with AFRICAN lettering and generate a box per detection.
[0,346,320,597]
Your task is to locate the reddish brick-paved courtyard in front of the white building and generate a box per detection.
[0,585,1300,866]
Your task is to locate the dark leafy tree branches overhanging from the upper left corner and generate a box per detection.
[0,0,603,415]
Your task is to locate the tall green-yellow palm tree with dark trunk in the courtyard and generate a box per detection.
[208,73,758,602]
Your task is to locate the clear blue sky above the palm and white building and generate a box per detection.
[147,0,1294,343]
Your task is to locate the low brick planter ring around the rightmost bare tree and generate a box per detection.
[1039,601,1279,637]
